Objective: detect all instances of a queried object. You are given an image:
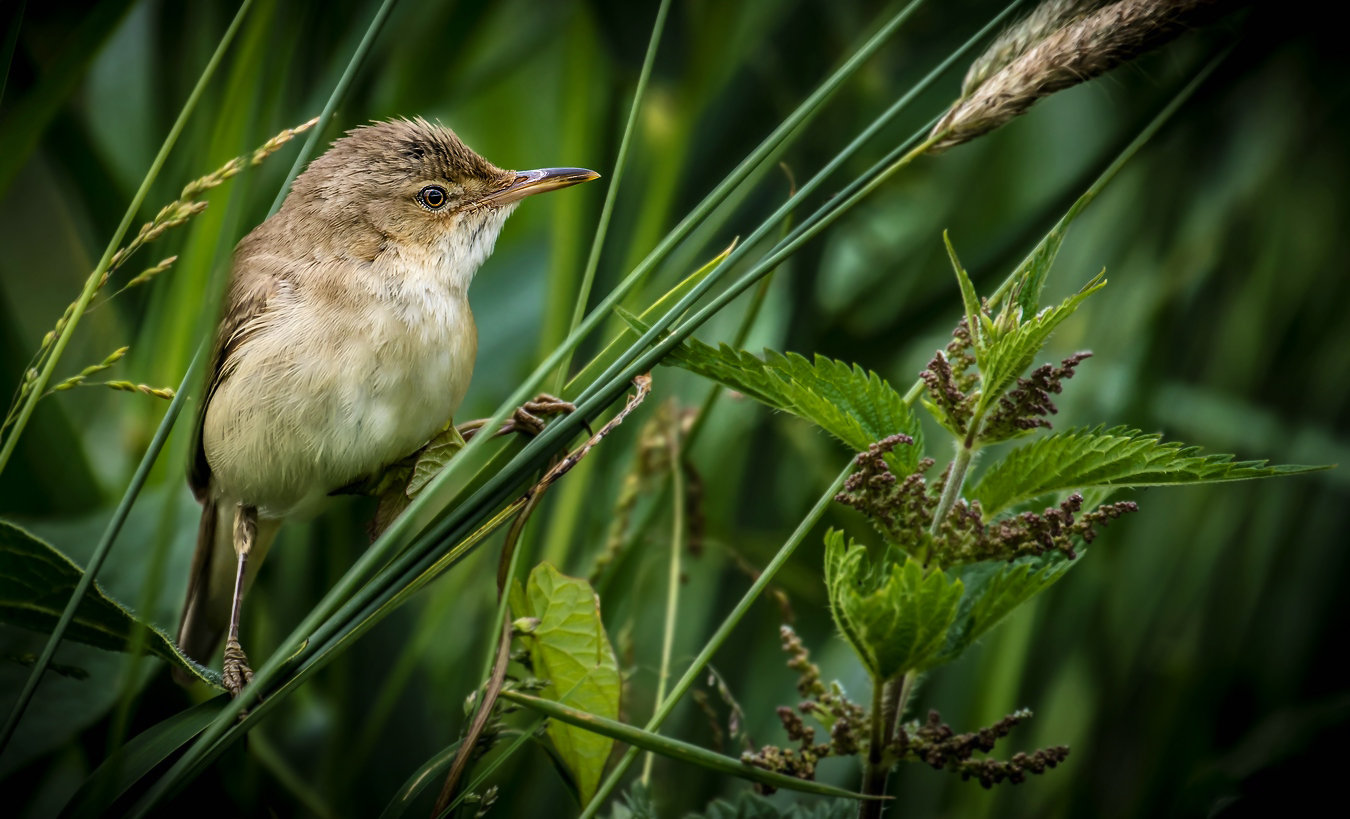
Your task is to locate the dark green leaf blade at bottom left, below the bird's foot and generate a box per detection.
[61,696,228,819]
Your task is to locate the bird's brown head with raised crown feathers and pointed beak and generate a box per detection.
[282,117,599,275]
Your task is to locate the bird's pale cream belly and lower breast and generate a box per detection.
[203,305,477,517]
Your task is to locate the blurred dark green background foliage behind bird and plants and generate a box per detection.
[0,0,1350,816]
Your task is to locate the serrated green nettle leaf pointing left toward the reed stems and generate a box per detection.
[625,316,923,475]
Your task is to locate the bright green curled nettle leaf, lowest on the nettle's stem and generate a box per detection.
[825,530,964,680]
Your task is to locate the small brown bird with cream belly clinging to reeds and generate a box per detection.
[178,119,599,695]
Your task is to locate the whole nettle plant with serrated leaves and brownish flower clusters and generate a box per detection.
[650,229,1318,816]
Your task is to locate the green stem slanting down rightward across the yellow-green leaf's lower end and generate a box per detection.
[502,689,869,799]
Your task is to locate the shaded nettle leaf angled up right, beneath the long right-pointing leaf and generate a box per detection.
[934,553,1083,665]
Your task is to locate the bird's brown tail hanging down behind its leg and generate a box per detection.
[173,498,279,685]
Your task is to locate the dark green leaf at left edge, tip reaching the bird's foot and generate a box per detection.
[0,521,223,688]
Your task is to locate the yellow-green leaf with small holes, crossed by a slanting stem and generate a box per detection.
[510,563,621,804]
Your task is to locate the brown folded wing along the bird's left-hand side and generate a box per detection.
[188,256,279,502]
